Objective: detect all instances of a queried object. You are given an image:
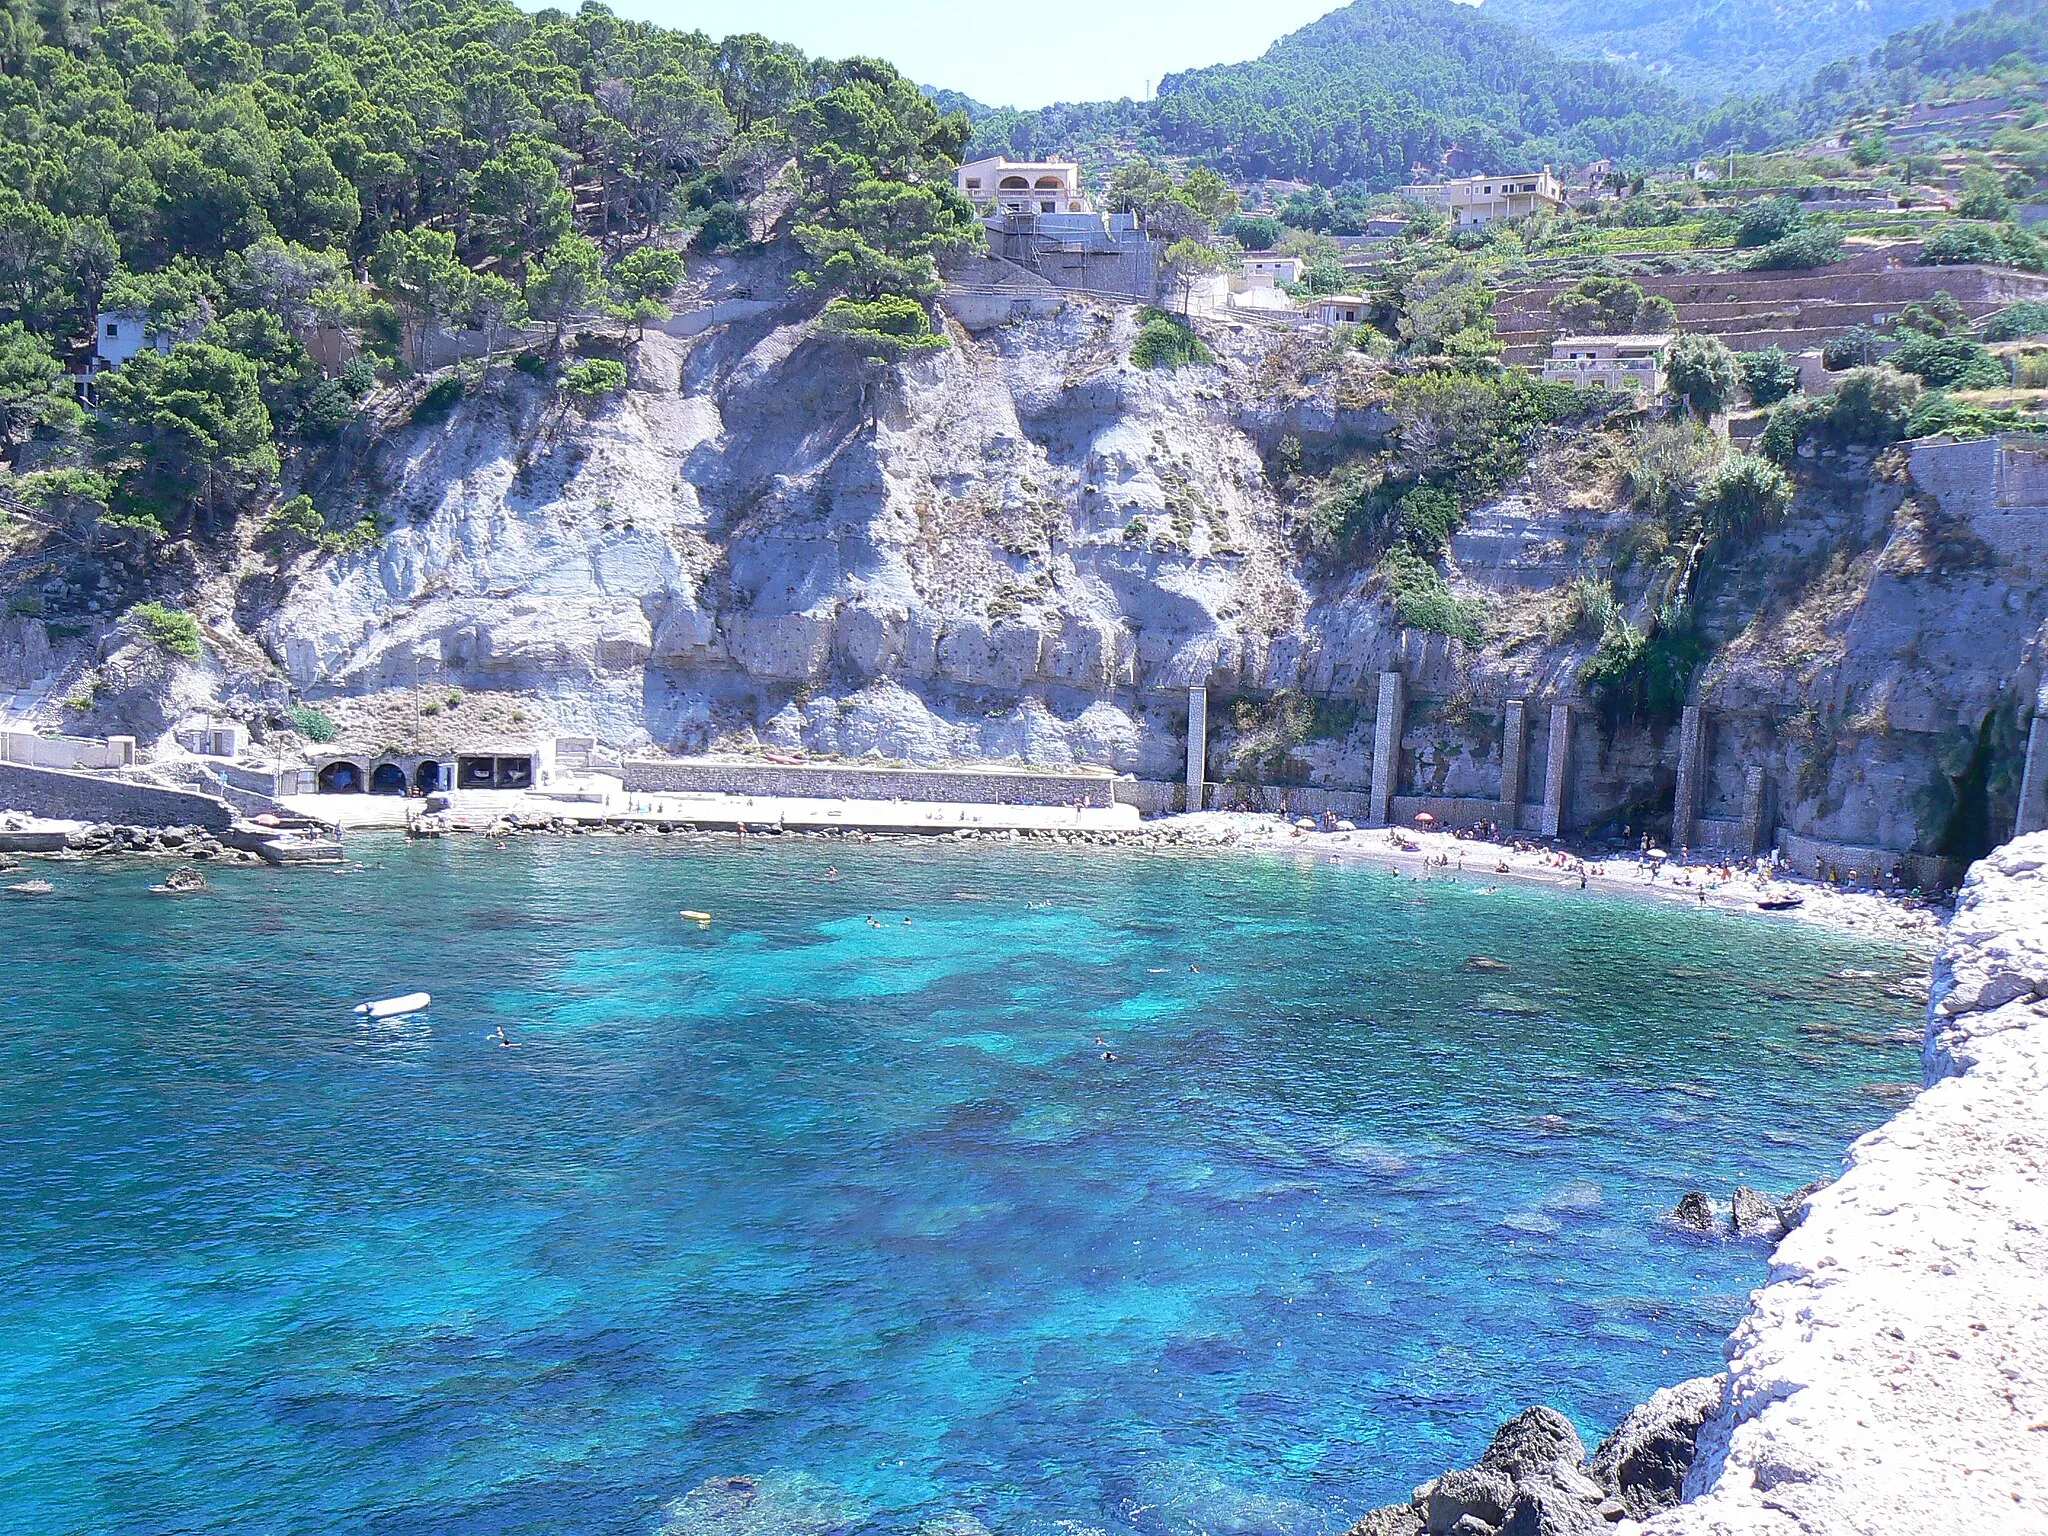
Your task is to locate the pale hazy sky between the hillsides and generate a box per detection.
[553,0,1343,106]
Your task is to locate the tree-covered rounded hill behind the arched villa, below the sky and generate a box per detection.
[973,0,1728,190]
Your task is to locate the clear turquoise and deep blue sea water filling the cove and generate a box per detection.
[0,840,1915,1536]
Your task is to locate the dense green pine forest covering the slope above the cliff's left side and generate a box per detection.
[0,0,979,539]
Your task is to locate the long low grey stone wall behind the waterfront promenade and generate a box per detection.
[621,758,1145,811]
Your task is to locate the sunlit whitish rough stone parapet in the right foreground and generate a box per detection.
[1645,834,2048,1536]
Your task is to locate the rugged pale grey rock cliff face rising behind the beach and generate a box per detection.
[12,260,2048,872]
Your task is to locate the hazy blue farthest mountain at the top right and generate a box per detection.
[1483,0,1968,98]
